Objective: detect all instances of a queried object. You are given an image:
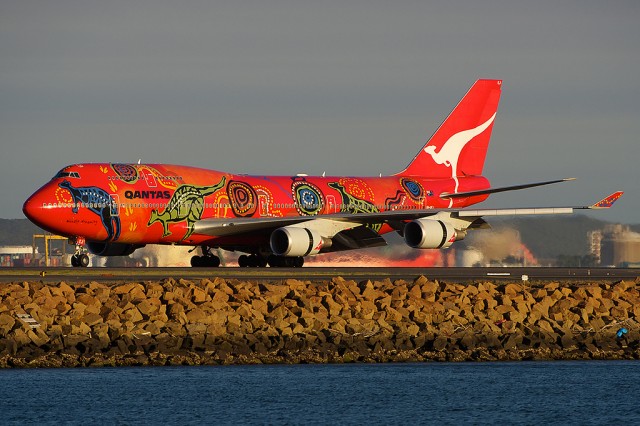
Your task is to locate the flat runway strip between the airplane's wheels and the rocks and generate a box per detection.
[0,267,640,282]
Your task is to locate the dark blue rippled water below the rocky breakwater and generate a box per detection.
[0,361,640,425]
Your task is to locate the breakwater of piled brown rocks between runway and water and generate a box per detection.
[0,277,640,367]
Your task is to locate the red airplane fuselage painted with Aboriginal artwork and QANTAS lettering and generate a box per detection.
[25,163,489,248]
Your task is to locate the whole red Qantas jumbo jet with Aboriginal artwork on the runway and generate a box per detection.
[23,80,622,267]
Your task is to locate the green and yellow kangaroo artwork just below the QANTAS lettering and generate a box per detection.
[147,176,227,240]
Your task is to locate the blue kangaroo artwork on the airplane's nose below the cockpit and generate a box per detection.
[58,179,121,241]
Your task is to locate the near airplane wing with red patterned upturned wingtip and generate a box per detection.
[194,191,623,243]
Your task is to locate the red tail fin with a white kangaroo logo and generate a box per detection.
[398,80,502,178]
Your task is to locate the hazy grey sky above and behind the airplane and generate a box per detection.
[0,0,640,224]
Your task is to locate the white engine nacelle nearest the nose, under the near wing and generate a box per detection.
[269,226,325,257]
